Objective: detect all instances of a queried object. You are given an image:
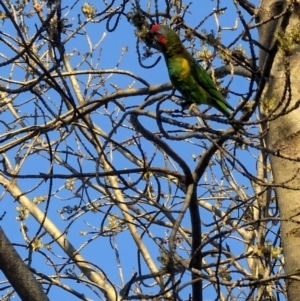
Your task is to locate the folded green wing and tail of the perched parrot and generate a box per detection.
[189,57,234,117]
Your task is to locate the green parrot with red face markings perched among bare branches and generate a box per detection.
[151,24,234,117]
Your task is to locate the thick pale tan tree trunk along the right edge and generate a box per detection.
[257,0,300,301]
